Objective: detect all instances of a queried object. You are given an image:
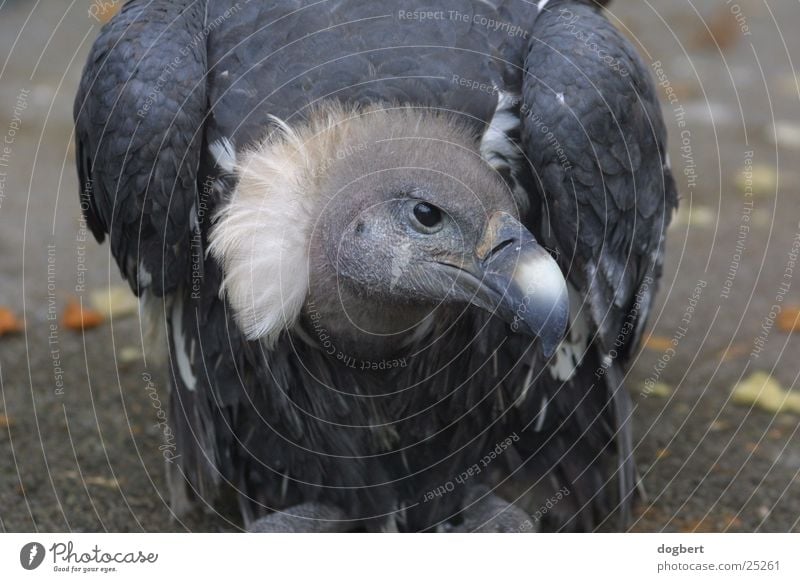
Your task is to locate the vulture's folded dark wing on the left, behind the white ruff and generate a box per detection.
[74,2,206,295]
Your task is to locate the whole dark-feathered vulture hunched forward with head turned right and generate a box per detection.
[74,0,677,532]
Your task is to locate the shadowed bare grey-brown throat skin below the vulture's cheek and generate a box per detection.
[301,244,435,367]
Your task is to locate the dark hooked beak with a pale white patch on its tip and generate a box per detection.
[442,212,569,357]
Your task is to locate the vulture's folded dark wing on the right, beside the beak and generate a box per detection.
[521,2,677,521]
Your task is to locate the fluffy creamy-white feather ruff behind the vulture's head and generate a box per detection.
[209,105,362,345]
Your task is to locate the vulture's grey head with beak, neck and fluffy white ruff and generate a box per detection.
[211,105,569,357]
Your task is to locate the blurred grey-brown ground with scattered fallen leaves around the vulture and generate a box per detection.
[0,0,800,531]
